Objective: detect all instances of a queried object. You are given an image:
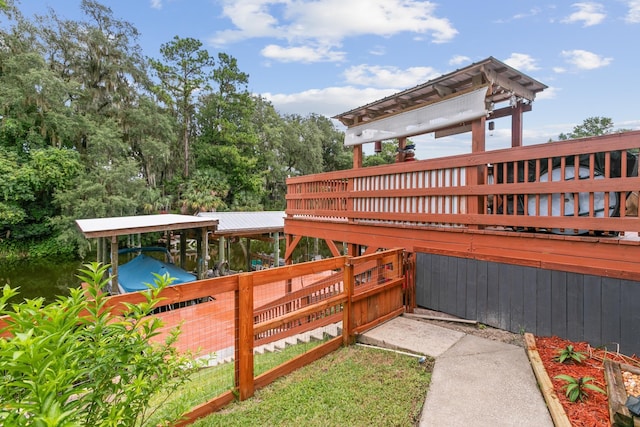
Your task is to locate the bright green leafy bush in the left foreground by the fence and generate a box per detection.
[0,263,196,427]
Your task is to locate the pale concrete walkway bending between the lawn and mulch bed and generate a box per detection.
[358,316,553,427]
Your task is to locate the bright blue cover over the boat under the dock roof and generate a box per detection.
[118,254,196,292]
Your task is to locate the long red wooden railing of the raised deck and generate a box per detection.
[286,131,640,234]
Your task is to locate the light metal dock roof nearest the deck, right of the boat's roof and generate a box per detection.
[198,211,285,236]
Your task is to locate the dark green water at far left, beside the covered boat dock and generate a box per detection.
[0,259,83,302]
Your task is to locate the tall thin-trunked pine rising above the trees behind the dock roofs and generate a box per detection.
[149,36,215,178]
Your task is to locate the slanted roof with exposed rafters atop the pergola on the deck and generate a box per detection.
[333,57,547,127]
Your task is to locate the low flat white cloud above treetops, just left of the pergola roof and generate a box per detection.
[261,86,397,117]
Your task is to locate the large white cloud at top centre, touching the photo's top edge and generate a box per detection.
[209,0,458,60]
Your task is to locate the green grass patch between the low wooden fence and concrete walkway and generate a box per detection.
[193,345,433,427]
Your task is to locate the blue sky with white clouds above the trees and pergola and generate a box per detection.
[12,0,640,159]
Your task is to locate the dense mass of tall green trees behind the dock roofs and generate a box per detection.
[0,0,352,256]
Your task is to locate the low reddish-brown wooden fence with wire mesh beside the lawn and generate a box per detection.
[0,249,405,426]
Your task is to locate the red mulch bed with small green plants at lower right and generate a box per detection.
[535,337,640,427]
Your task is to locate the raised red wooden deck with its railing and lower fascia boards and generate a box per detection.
[285,131,640,280]
